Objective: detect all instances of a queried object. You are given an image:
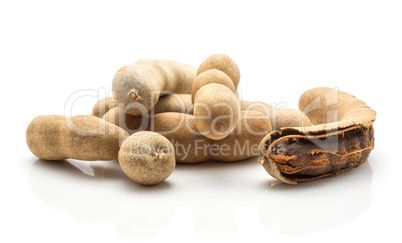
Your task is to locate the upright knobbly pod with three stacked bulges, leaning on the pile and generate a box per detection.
[191,54,240,140]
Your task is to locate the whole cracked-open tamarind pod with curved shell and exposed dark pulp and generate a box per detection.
[259,87,376,184]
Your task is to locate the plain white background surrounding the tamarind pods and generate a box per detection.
[0,0,402,242]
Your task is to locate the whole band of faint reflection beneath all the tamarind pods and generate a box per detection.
[29,158,372,240]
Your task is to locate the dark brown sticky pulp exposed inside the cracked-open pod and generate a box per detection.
[267,126,374,181]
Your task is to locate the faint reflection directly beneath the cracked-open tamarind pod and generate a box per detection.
[259,162,373,235]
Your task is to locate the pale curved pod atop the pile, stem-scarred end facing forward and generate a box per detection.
[112,59,197,116]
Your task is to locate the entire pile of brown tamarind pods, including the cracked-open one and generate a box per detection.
[26,54,376,185]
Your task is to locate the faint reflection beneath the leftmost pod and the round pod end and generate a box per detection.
[29,159,175,239]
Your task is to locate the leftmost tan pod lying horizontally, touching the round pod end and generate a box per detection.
[26,115,128,161]
